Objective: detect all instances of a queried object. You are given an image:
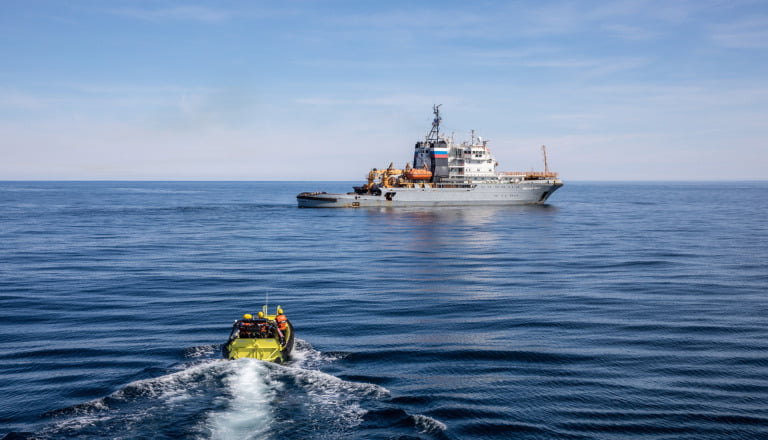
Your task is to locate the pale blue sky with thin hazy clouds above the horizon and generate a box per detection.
[0,0,768,182]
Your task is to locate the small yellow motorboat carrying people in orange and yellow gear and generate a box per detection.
[222,306,294,363]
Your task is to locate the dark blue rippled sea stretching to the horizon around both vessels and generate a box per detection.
[0,182,768,440]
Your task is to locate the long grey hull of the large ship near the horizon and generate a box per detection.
[296,181,563,208]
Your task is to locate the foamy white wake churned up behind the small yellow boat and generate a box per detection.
[30,340,445,440]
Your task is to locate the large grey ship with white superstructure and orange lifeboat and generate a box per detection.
[296,105,563,208]
